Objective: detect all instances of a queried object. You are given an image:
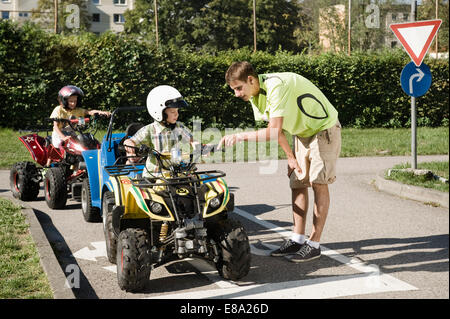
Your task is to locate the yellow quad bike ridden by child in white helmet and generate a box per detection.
[102,148,251,292]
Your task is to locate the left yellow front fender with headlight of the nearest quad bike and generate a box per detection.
[109,176,175,221]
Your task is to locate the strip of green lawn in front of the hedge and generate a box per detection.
[0,127,449,169]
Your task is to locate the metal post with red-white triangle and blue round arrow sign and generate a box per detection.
[389,20,442,169]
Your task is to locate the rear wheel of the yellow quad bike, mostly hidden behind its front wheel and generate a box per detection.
[102,191,117,264]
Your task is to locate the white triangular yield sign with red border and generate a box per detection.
[389,20,442,66]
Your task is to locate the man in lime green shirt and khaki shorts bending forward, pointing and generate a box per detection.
[219,61,341,262]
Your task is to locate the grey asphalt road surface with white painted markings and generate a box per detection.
[0,156,449,302]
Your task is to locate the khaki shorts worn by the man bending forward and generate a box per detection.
[289,121,341,189]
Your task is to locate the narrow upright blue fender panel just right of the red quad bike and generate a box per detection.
[81,150,102,208]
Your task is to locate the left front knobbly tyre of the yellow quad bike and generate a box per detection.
[116,228,151,292]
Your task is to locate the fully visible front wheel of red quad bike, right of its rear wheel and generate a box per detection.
[44,166,67,209]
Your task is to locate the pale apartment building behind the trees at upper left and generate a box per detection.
[0,0,135,34]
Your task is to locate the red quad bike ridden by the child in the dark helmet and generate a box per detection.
[10,115,101,214]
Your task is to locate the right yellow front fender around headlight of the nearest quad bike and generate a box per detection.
[203,178,234,218]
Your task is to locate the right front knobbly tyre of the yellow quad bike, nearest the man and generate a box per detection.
[208,218,251,280]
